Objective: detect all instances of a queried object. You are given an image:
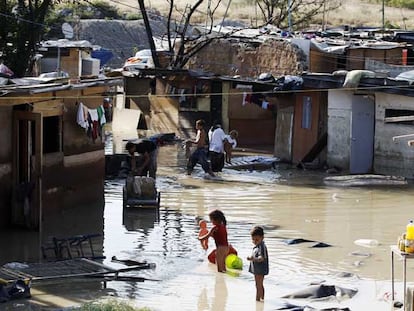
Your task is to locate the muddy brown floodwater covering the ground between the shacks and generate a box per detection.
[0,140,414,311]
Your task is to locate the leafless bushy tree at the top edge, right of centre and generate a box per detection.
[256,0,340,29]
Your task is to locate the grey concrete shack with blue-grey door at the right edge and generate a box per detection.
[305,70,414,179]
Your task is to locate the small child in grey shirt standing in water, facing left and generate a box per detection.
[247,226,269,301]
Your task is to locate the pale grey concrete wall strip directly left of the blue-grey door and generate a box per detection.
[327,90,353,170]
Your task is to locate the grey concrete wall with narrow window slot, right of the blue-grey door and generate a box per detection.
[374,93,414,179]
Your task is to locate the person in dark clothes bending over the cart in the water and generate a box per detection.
[125,139,158,179]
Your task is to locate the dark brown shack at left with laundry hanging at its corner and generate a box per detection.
[0,78,122,229]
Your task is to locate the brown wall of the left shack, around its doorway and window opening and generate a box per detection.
[0,86,108,228]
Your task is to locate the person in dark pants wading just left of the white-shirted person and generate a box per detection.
[186,120,215,177]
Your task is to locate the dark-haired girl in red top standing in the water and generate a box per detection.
[198,210,229,272]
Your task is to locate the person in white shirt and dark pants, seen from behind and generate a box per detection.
[208,124,226,172]
